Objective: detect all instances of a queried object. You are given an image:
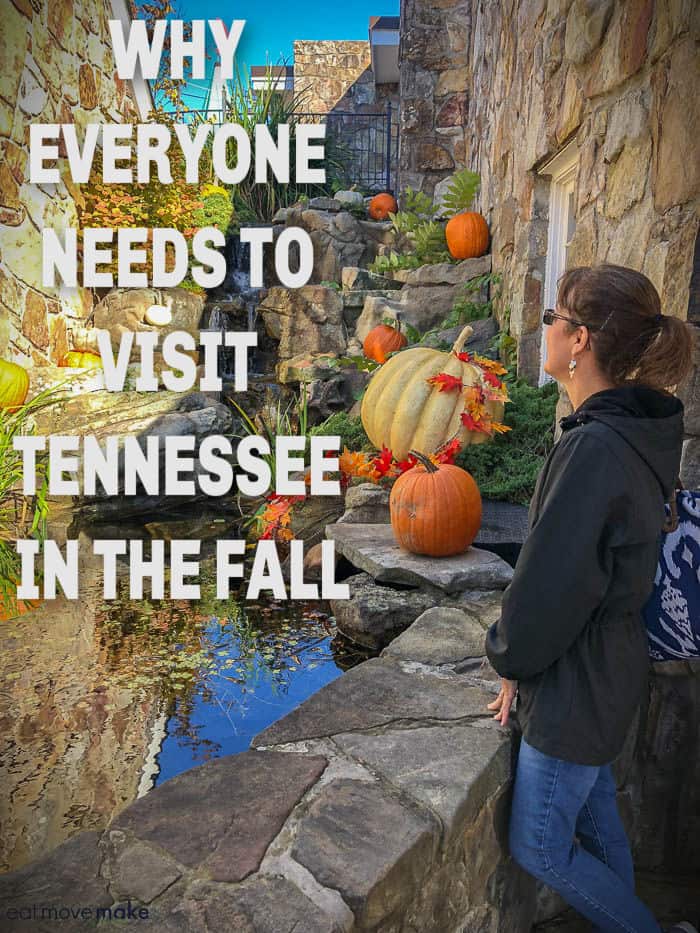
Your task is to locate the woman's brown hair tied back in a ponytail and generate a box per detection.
[557,263,692,390]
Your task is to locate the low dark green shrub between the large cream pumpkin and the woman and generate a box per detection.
[456,374,558,505]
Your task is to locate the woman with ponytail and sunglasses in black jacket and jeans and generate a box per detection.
[486,265,694,933]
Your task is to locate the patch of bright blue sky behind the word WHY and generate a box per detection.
[175,0,399,106]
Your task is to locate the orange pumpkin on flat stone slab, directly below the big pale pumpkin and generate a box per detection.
[389,450,481,557]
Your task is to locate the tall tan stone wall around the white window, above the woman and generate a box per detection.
[399,0,700,382]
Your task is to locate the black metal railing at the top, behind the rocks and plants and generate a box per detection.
[174,102,399,194]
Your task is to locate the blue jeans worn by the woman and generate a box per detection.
[510,739,661,933]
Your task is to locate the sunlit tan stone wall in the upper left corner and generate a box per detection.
[0,0,142,366]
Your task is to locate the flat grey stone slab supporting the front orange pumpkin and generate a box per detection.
[326,523,513,593]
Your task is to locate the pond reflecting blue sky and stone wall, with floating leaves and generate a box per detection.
[0,515,370,871]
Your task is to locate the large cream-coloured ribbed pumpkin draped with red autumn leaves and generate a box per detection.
[360,324,504,460]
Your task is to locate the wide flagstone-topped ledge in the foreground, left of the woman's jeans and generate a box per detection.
[0,659,534,933]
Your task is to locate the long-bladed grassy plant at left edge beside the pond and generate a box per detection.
[0,380,70,611]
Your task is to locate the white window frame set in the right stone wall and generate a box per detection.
[538,140,579,385]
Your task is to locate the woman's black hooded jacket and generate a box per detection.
[486,386,683,765]
